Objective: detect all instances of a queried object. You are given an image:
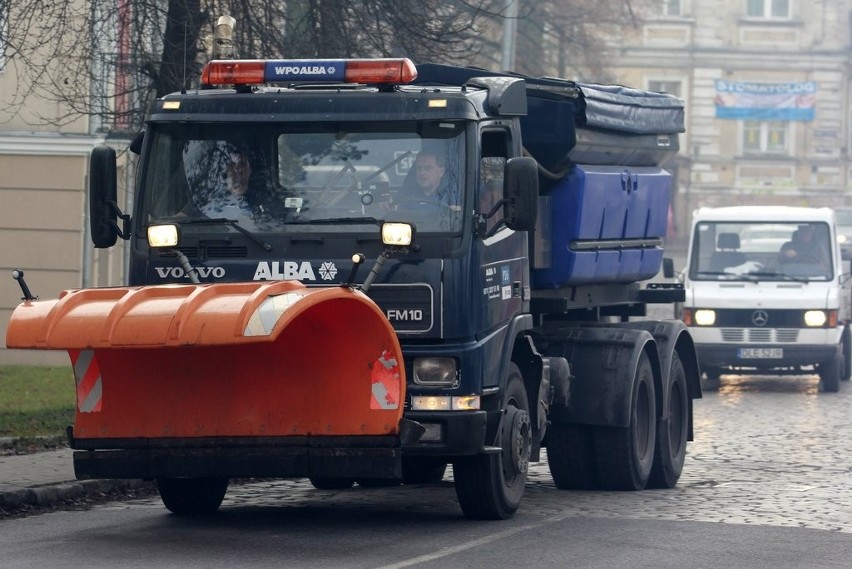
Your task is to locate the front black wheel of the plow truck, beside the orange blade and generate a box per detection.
[453,364,532,520]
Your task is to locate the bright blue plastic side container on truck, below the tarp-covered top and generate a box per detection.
[532,165,671,288]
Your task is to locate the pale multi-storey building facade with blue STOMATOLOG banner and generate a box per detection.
[610,0,852,238]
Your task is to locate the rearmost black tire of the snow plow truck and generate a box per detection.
[647,351,689,488]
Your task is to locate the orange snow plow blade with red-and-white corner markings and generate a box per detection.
[6,281,405,440]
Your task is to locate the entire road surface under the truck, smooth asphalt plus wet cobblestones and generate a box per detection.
[0,370,852,569]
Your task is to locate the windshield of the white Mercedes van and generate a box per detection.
[689,222,833,281]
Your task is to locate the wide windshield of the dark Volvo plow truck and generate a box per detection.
[141,121,465,233]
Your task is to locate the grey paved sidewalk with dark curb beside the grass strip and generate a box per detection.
[0,441,145,512]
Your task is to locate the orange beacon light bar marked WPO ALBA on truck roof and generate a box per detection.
[201,57,417,85]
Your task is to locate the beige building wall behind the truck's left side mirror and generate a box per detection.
[0,2,126,365]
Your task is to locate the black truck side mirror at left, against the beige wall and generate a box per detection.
[89,145,130,249]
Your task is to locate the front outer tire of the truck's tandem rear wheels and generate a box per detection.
[594,352,657,490]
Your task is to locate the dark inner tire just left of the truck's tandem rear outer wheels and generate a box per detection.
[547,423,597,490]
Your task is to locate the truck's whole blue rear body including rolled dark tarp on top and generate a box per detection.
[521,79,684,288]
